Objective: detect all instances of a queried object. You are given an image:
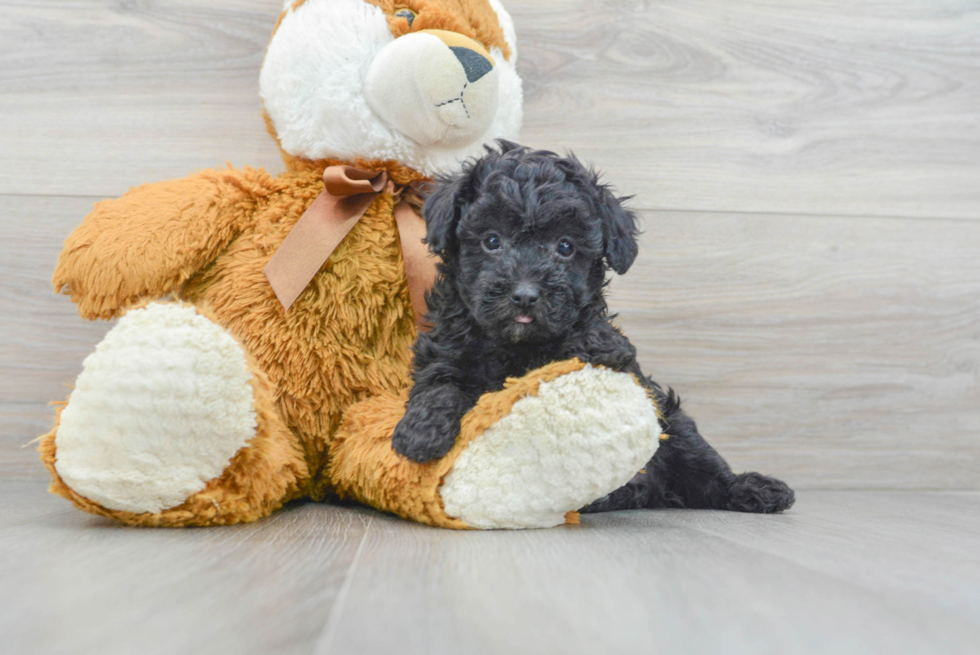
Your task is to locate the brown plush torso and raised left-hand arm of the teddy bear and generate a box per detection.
[54,160,422,498]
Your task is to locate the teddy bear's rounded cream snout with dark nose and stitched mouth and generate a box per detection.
[364,30,498,147]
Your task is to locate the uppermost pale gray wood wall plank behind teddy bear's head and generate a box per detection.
[0,0,980,219]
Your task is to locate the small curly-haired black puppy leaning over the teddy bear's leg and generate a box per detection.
[392,141,794,512]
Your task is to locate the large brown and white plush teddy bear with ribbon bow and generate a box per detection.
[40,0,660,528]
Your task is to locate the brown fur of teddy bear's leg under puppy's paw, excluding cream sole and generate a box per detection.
[330,359,585,529]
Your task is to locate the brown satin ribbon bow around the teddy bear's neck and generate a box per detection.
[265,166,439,323]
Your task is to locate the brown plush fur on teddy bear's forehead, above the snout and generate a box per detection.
[273,0,511,60]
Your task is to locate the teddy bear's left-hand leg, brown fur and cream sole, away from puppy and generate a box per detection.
[40,303,309,526]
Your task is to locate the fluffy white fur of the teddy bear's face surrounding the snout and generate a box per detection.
[260,0,523,175]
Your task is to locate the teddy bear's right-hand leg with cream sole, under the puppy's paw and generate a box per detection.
[330,360,661,529]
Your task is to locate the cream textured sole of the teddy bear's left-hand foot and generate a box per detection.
[55,303,257,513]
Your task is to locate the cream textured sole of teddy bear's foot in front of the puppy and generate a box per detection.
[440,366,660,529]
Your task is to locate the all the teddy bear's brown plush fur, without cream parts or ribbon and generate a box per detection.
[39,0,560,528]
